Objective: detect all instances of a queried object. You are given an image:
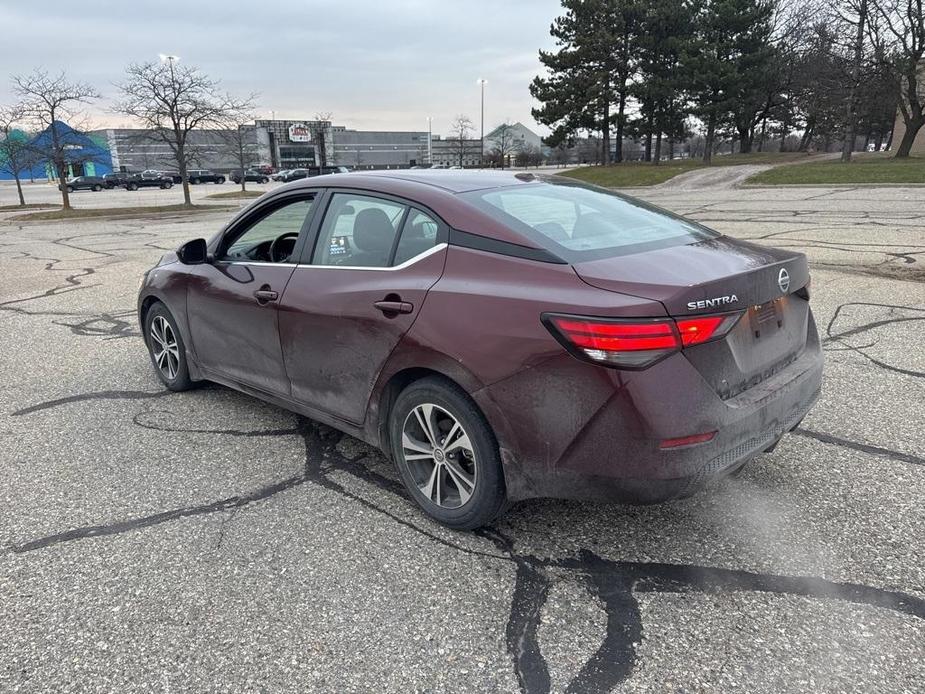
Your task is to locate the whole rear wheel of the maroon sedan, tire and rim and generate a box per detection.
[389,378,505,530]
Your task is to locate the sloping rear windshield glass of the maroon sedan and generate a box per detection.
[461,176,720,262]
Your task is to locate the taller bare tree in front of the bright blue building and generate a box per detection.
[13,69,99,210]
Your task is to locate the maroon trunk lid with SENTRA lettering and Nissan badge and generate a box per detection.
[573,237,809,399]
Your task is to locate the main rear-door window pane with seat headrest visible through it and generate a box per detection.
[312,193,407,267]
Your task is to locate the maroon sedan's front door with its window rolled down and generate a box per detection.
[187,193,314,395]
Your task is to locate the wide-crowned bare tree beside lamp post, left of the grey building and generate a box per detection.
[115,57,255,205]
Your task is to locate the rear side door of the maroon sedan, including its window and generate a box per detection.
[279,191,447,423]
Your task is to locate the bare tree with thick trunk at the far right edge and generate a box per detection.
[869,0,925,158]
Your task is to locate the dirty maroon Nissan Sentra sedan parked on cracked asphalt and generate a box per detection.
[138,171,822,528]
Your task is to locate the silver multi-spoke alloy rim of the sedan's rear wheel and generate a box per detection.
[401,403,478,509]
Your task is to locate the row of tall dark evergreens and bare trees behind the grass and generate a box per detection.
[531,0,925,164]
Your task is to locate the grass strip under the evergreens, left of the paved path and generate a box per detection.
[560,152,811,188]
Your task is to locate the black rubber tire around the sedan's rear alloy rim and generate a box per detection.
[389,377,506,530]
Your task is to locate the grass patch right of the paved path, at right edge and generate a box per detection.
[747,152,925,186]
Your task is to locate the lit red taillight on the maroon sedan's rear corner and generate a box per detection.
[543,313,741,369]
